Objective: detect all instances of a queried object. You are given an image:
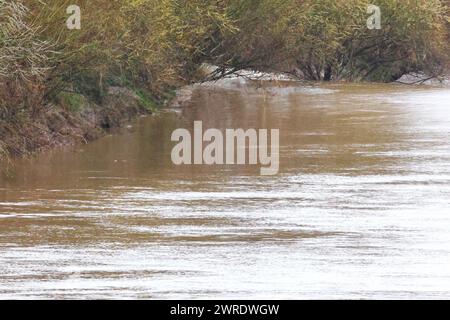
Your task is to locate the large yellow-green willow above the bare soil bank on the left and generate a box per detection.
[21,0,233,100]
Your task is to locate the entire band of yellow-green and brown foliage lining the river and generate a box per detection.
[0,0,450,158]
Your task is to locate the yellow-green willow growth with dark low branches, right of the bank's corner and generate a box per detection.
[206,0,449,81]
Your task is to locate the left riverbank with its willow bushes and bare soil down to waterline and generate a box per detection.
[0,0,228,169]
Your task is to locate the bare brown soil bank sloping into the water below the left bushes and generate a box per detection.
[0,87,151,167]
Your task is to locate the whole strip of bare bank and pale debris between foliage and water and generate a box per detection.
[0,66,449,167]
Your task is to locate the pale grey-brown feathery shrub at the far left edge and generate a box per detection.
[0,0,51,119]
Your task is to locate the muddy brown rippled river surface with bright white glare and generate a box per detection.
[0,80,450,299]
